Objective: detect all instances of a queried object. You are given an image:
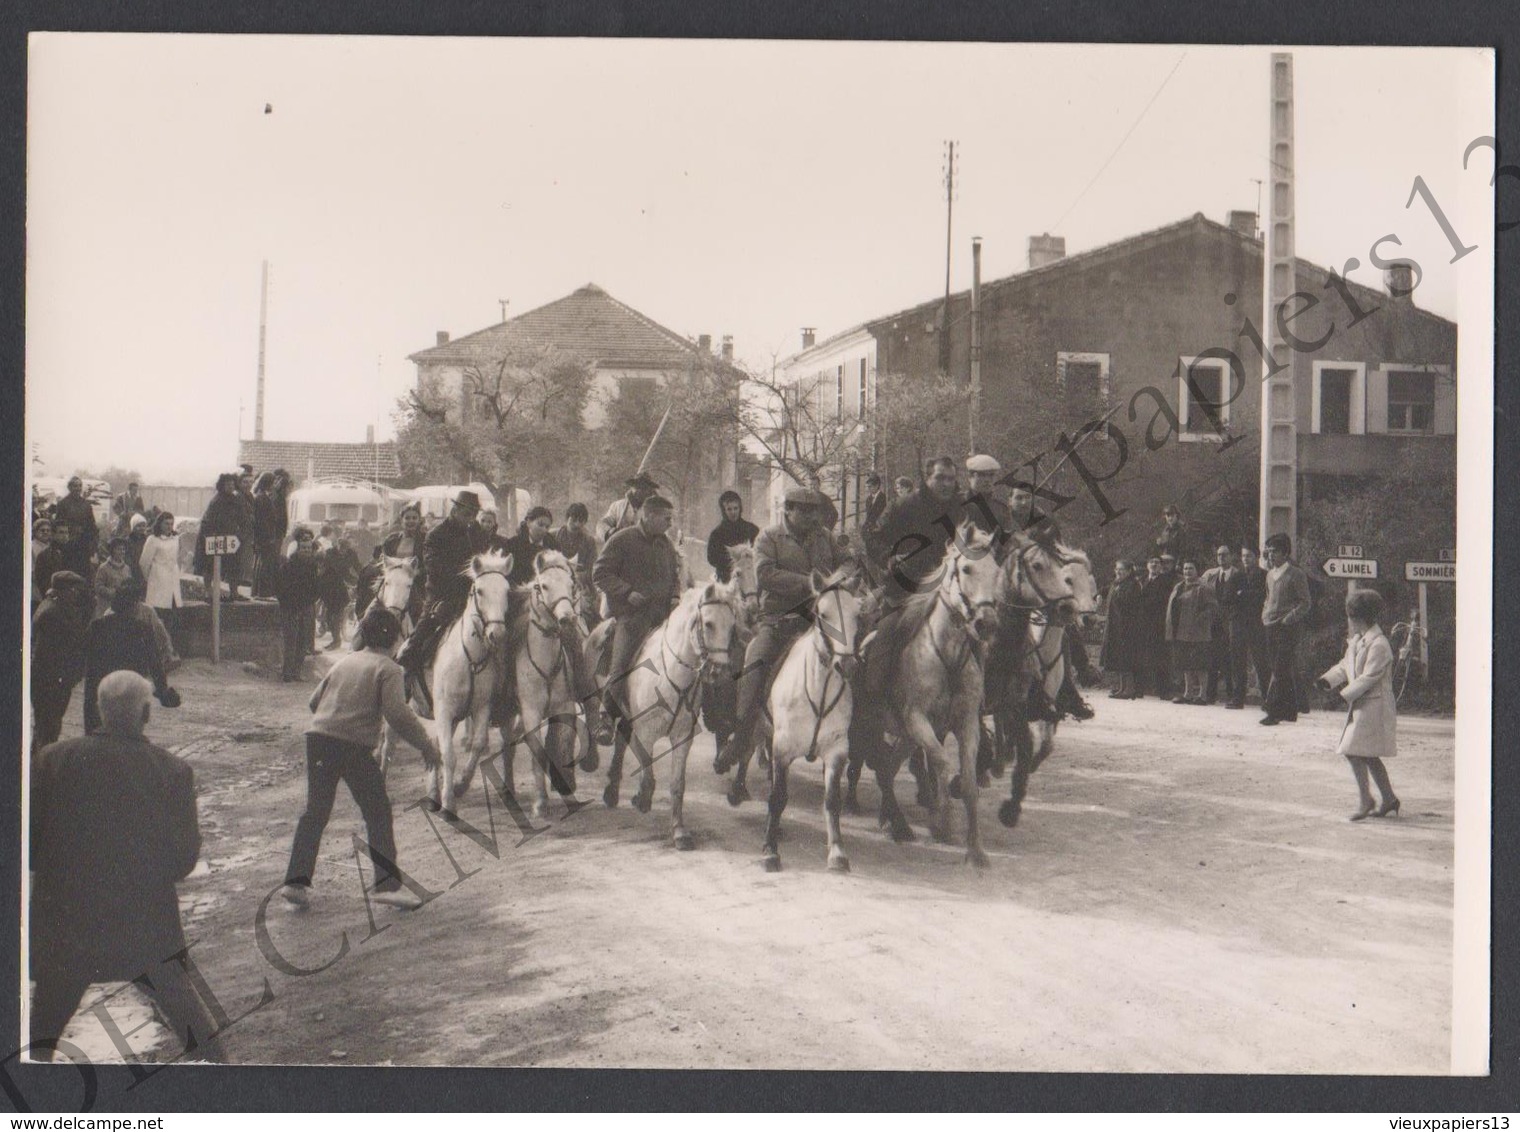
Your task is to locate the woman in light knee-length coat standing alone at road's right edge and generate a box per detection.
[1319,590,1398,822]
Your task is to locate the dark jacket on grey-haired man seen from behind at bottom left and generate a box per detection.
[30,734,201,982]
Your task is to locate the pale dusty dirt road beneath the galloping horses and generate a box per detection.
[44,662,1453,1073]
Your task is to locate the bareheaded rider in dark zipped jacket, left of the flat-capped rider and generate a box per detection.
[591,488,681,735]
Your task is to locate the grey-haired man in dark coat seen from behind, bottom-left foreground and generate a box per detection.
[30,672,226,1062]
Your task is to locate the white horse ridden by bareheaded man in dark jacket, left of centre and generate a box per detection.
[602,582,742,849]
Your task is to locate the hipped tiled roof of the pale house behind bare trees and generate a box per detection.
[410,283,729,369]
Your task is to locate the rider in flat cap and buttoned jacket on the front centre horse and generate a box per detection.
[714,486,841,773]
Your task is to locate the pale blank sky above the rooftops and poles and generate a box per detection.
[26,33,1493,483]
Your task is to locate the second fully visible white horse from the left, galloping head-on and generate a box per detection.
[502,550,581,817]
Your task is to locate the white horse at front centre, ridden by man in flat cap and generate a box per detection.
[758,568,860,872]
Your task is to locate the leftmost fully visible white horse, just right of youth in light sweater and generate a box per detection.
[427,555,512,821]
